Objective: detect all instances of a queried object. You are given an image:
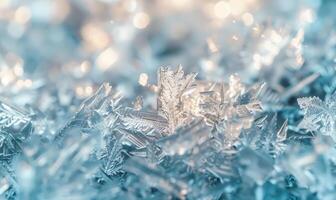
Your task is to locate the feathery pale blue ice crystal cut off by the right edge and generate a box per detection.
[298,93,336,141]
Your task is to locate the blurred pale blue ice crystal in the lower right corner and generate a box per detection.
[280,136,336,199]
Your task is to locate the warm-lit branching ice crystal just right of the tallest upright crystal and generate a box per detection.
[199,76,264,147]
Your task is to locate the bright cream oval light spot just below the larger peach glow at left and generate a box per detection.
[96,48,119,71]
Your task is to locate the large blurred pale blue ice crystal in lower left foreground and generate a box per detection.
[15,134,100,199]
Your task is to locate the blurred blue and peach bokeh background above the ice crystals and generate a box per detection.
[0,0,336,106]
